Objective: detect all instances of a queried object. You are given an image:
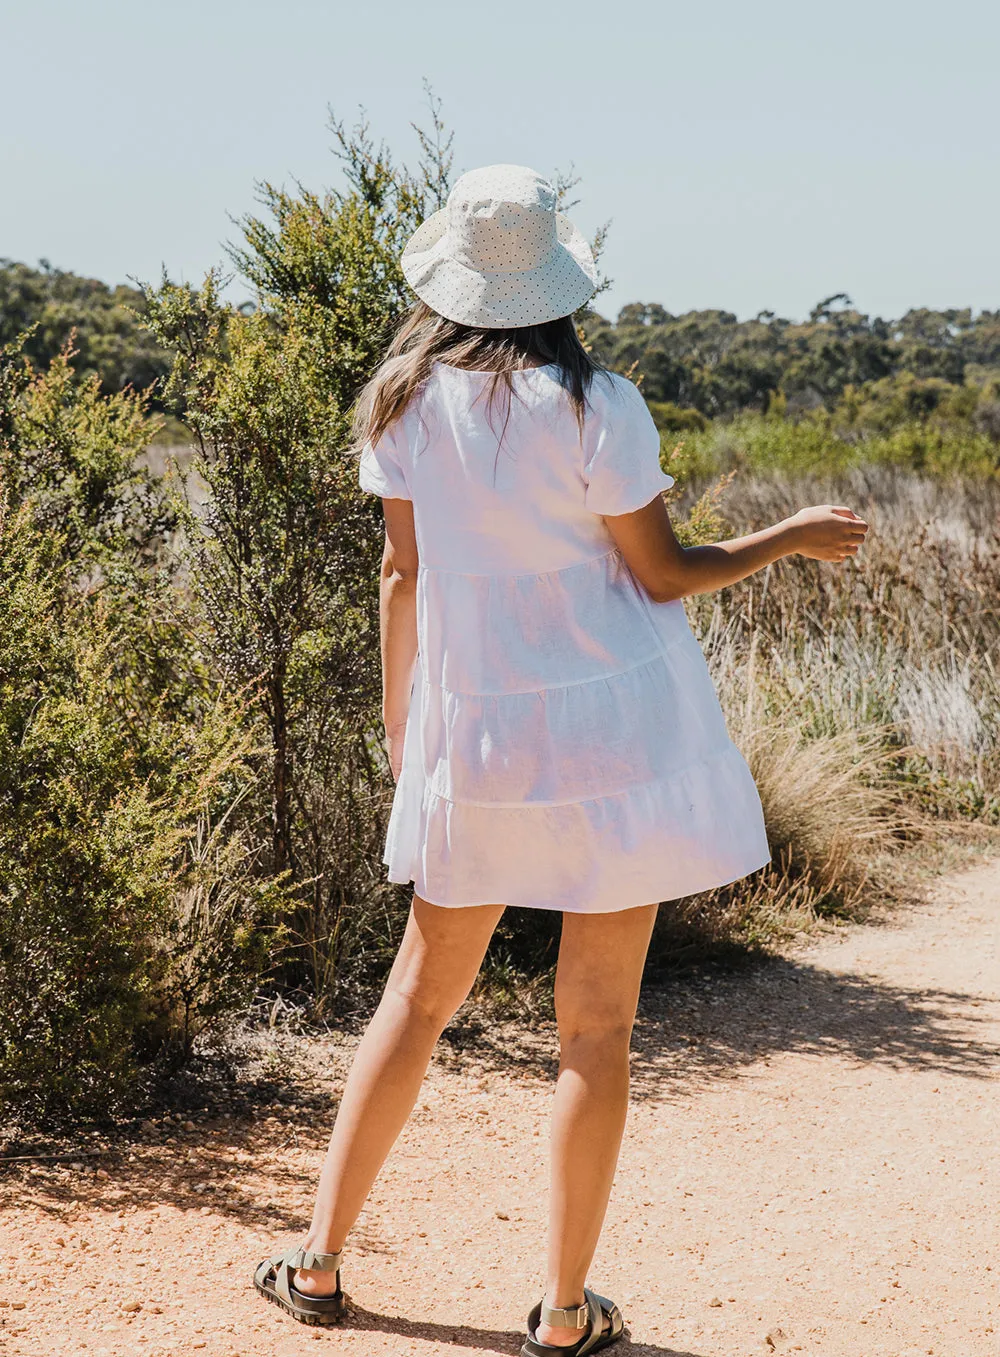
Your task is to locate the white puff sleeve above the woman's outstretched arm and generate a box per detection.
[583,375,673,514]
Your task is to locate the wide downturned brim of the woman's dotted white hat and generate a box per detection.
[400,208,597,330]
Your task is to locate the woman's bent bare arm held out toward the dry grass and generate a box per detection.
[604,495,868,603]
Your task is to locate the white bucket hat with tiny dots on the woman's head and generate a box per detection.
[400,166,597,330]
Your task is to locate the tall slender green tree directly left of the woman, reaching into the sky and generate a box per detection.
[148,106,450,993]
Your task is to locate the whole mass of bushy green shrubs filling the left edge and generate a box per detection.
[0,333,295,1124]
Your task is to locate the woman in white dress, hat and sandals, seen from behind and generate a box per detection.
[255,166,867,1357]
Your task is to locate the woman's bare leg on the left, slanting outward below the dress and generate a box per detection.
[296,896,503,1296]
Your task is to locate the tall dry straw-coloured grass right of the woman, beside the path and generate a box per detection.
[657,465,1000,959]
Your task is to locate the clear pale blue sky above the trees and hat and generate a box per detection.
[0,0,1000,316]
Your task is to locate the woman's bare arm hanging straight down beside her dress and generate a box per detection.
[379,499,419,780]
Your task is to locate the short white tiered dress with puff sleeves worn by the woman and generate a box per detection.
[360,364,769,913]
